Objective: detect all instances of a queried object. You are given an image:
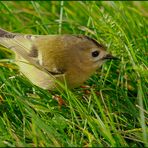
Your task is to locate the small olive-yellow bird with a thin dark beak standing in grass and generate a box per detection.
[0,29,115,90]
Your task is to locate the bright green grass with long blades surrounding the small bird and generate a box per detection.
[0,1,148,147]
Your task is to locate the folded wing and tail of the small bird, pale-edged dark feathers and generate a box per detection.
[0,29,61,75]
